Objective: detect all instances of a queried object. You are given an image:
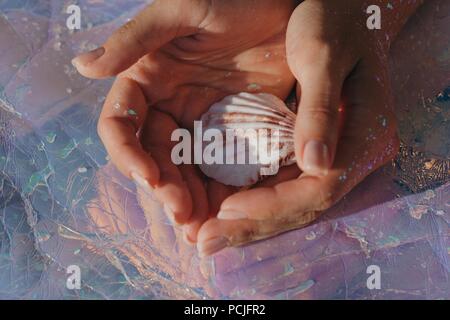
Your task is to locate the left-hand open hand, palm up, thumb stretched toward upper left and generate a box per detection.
[73,0,295,242]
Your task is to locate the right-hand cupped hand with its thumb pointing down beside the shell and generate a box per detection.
[198,0,428,255]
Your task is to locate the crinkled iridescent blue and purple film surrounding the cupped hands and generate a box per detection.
[0,0,450,299]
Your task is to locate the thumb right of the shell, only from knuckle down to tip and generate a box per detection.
[295,67,344,176]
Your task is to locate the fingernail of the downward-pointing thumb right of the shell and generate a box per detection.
[303,140,330,176]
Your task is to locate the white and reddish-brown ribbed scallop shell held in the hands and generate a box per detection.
[197,93,296,187]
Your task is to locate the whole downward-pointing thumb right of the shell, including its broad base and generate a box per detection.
[286,10,357,176]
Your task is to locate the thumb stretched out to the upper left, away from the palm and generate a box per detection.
[72,0,208,79]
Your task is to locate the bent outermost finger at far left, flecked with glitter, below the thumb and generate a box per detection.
[98,78,159,190]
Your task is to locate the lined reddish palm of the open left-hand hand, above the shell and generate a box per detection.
[124,2,294,127]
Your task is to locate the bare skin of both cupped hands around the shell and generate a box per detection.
[74,0,420,255]
